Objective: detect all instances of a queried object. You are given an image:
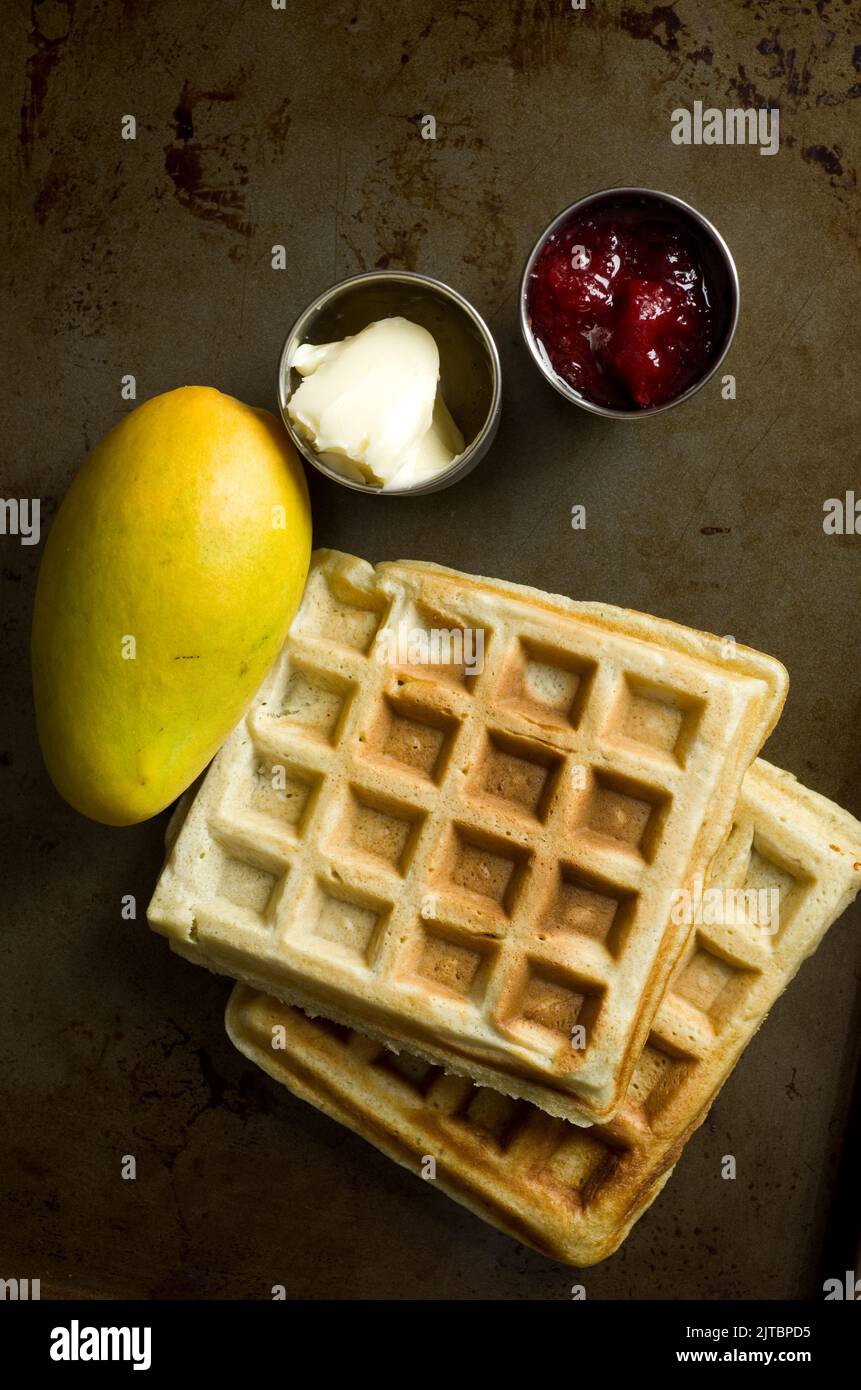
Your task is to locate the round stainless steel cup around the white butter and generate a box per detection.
[277,270,502,498]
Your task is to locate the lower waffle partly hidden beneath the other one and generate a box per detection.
[227,762,861,1265]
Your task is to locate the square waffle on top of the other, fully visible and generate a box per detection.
[149,550,786,1123]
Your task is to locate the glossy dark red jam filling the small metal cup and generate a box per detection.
[527,204,725,411]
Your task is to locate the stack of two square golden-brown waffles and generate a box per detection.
[149,552,861,1265]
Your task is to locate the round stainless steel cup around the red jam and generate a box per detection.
[520,188,740,420]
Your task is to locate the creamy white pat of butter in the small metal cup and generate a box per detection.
[288,317,463,489]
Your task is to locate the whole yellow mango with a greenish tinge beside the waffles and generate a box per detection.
[32,386,312,826]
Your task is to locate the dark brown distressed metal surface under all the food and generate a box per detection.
[0,0,861,1298]
